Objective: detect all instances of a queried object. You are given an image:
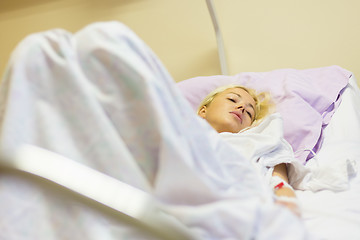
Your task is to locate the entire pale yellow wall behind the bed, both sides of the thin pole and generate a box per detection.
[0,0,360,85]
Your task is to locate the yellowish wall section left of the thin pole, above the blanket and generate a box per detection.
[0,0,220,81]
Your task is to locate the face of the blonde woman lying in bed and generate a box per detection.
[199,88,256,133]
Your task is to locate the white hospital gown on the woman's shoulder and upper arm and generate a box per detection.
[220,113,308,184]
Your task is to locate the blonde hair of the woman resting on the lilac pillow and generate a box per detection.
[197,84,275,125]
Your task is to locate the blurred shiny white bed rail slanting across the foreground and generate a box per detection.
[0,145,196,240]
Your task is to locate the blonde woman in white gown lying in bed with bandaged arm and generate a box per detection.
[197,85,300,215]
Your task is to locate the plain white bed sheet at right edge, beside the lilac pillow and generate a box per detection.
[296,76,360,240]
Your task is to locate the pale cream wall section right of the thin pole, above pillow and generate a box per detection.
[215,0,360,85]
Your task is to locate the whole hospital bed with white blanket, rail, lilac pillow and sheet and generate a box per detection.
[0,11,360,240]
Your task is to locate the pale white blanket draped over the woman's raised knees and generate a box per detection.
[0,22,316,240]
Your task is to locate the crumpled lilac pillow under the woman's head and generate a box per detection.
[177,66,352,163]
